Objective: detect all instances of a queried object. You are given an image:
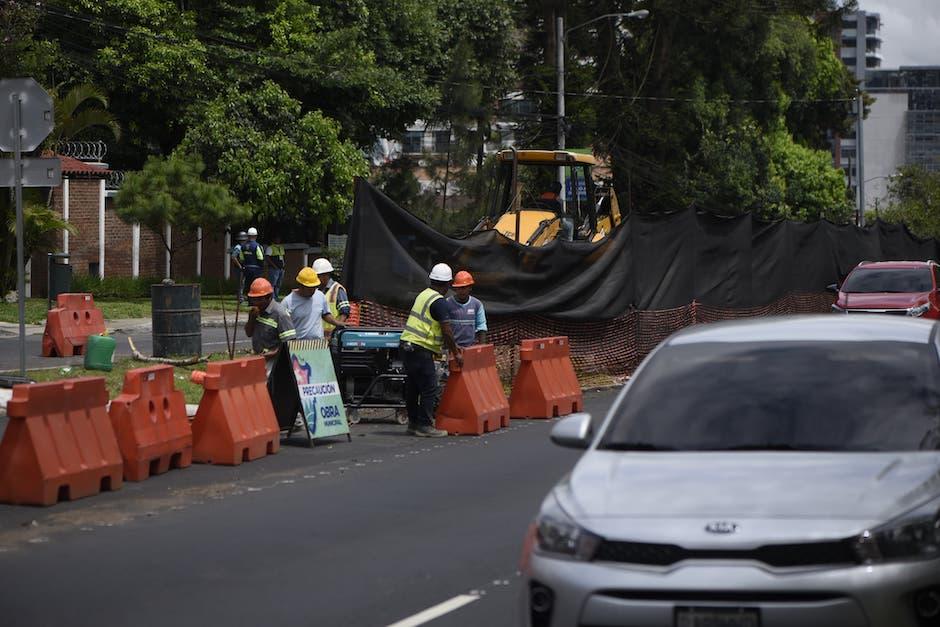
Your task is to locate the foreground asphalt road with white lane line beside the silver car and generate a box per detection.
[0,391,615,627]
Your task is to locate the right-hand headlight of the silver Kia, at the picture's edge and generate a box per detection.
[855,500,940,564]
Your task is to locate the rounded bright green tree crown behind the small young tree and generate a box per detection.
[180,81,367,222]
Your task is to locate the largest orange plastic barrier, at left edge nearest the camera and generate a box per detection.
[0,377,123,505]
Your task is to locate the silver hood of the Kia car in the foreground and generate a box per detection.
[555,450,940,540]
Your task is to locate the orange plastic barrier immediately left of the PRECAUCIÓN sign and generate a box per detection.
[192,357,280,466]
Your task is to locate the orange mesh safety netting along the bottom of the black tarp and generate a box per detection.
[355,293,835,380]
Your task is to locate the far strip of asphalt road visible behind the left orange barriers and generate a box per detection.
[0,325,251,372]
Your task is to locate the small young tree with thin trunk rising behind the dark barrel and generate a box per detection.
[115,153,249,278]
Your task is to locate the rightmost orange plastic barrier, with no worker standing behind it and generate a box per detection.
[509,337,584,418]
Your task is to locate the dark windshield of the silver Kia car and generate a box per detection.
[600,341,940,451]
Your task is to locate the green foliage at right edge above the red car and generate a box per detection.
[878,165,940,239]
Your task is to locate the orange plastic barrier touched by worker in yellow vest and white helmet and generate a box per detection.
[435,344,509,435]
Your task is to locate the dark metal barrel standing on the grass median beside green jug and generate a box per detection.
[150,285,202,357]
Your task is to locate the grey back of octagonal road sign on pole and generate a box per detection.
[0,78,55,152]
